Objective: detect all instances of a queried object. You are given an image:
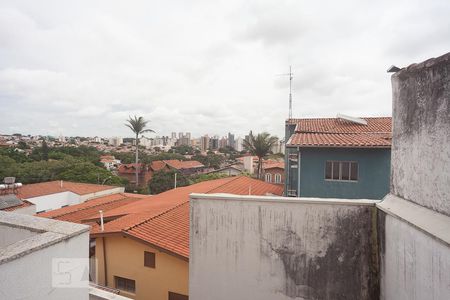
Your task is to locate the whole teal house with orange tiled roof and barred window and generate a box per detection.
[285,115,392,199]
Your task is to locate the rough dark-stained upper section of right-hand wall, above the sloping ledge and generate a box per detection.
[391,53,450,215]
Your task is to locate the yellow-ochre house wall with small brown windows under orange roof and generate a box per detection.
[95,235,189,300]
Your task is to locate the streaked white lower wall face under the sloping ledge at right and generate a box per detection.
[380,212,450,300]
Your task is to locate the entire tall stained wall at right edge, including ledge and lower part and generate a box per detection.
[377,53,450,300]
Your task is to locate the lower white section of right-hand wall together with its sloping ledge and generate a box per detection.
[377,195,450,300]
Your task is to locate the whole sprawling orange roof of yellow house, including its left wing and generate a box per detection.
[39,176,283,258]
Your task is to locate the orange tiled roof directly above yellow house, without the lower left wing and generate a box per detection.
[91,176,283,258]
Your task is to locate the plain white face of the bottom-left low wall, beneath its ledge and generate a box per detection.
[0,232,89,300]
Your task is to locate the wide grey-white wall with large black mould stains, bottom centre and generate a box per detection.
[189,195,378,300]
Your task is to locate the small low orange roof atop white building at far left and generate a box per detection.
[17,180,117,199]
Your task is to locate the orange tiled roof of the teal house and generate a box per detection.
[287,117,392,148]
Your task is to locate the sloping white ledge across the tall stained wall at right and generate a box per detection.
[376,194,450,246]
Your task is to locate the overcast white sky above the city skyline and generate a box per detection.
[0,0,450,137]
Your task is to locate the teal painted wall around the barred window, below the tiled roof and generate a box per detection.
[300,148,391,199]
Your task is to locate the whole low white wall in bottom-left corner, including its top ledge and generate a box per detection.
[0,213,89,300]
